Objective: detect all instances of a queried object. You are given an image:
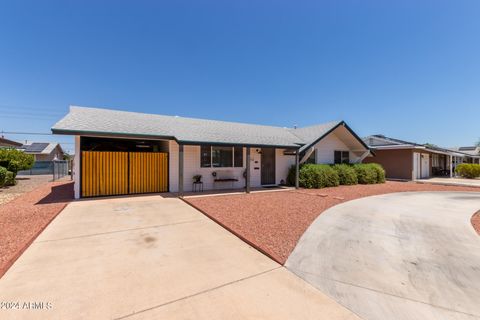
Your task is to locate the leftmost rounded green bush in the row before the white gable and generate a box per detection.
[299,164,340,189]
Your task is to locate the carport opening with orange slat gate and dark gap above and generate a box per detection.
[80,137,168,197]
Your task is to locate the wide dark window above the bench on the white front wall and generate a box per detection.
[200,145,243,168]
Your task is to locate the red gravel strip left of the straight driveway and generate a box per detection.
[0,181,73,277]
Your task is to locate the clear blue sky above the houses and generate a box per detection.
[0,0,480,149]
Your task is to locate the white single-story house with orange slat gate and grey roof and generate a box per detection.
[52,106,370,198]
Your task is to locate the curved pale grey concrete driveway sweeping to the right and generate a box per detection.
[286,192,480,320]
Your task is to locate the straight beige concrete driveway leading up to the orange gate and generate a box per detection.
[0,196,358,320]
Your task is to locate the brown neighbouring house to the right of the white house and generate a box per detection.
[363,135,480,180]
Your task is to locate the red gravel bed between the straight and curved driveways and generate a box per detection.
[185,182,480,264]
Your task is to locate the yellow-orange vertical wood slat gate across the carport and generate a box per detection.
[81,151,168,197]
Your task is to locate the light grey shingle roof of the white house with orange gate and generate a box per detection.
[52,106,356,148]
